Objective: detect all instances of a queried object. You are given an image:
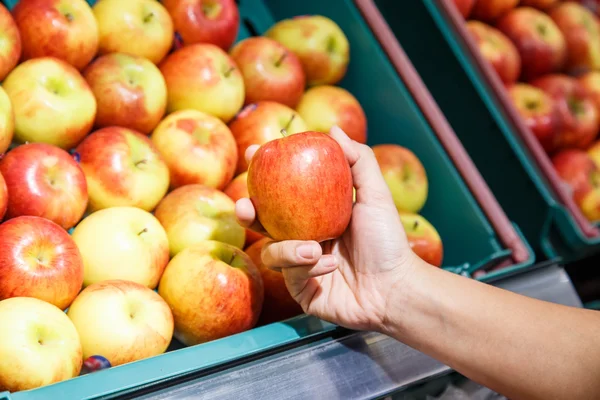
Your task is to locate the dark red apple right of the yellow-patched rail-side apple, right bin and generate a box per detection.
[531,74,600,148]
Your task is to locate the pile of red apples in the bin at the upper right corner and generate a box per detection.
[454,0,600,221]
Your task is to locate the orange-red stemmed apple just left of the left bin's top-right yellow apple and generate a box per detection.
[229,36,306,108]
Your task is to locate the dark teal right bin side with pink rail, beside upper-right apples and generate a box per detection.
[375,0,600,262]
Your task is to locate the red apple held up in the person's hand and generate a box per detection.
[248,131,353,242]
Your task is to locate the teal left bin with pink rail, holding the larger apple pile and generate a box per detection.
[0,0,534,400]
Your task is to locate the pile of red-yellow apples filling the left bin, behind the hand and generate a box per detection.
[0,0,442,392]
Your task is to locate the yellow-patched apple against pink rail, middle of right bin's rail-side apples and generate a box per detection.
[508,83,559,152]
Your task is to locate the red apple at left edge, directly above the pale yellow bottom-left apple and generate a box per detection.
[0,216,83,310]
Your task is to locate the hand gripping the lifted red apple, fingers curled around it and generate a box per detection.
[236,127,417,330]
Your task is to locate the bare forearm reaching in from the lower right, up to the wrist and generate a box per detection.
[382,265,600,399]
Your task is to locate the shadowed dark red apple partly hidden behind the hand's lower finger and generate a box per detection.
[245,238,303,326]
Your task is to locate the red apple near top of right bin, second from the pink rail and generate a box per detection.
[496,7,567,81]
